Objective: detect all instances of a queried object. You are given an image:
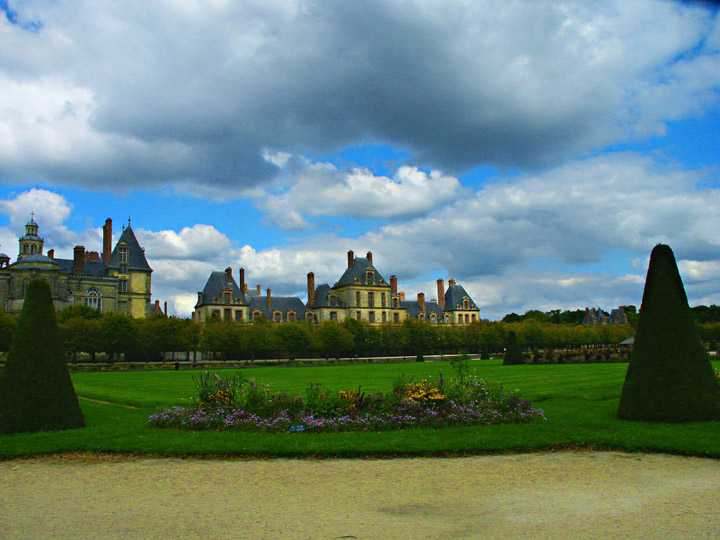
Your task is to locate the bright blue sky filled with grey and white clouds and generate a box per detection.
[0,0,720,320]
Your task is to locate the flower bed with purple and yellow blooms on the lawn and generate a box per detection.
[149,364,544,433]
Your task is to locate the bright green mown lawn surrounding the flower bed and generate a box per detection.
[0,360,720,458]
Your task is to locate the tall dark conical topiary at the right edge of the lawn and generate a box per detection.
[618,244,720,422]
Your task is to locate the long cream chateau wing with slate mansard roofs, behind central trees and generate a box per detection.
[193,251,480,325]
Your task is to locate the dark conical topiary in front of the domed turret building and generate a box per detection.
[0,279,85,433]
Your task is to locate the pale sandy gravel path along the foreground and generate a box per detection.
[0,452,720,540]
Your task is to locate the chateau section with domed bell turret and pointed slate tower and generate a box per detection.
[0,216,152,317]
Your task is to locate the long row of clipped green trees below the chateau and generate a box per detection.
[0,306,640,361]
